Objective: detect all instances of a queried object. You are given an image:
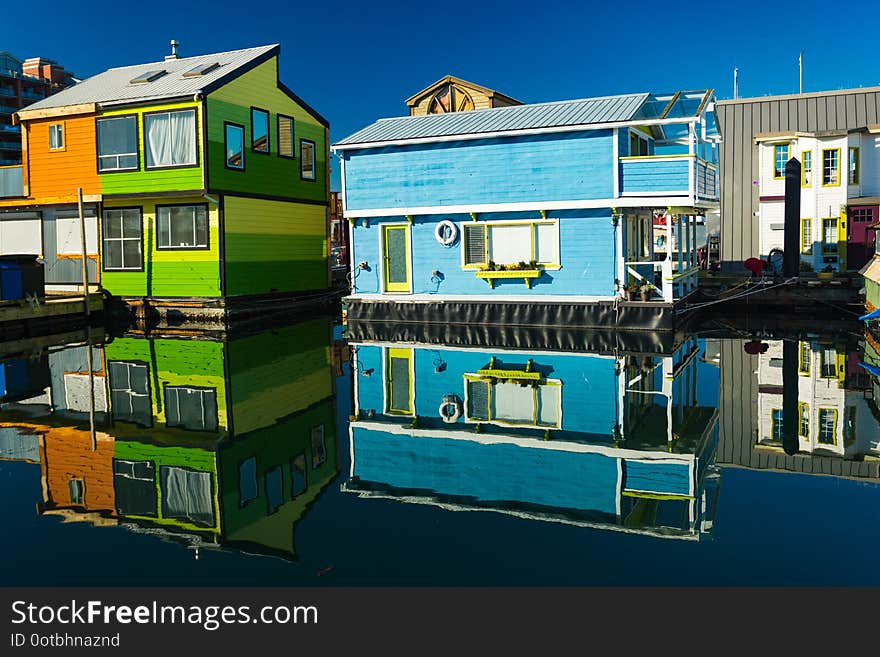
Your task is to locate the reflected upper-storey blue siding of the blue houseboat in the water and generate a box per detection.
[352,425,618,517]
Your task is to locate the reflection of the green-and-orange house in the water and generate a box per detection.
[0,318,339,559]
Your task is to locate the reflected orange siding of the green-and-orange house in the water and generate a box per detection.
[43,427,116,515]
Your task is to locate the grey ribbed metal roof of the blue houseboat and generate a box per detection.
[334,93,650,148]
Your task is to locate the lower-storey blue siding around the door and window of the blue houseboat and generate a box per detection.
[352,209,617,300]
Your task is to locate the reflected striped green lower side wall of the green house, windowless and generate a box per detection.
[228,318,333,435]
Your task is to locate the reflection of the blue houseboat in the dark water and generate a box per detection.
[346,340,717,537]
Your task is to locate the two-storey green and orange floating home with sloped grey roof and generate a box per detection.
[0,43,329,318]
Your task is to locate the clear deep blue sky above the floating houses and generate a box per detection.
[0,0,880,187]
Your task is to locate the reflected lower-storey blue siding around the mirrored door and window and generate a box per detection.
[357,345,618,442]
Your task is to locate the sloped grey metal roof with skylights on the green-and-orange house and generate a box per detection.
[22,44,279,112]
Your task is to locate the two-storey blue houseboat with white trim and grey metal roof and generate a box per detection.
[333,90,718,328]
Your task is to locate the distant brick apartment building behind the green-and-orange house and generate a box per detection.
[0,50,75,166]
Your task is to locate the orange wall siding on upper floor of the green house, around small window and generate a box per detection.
[26,115,101,202]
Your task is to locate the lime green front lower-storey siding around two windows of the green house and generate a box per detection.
[99,196,220,297]
